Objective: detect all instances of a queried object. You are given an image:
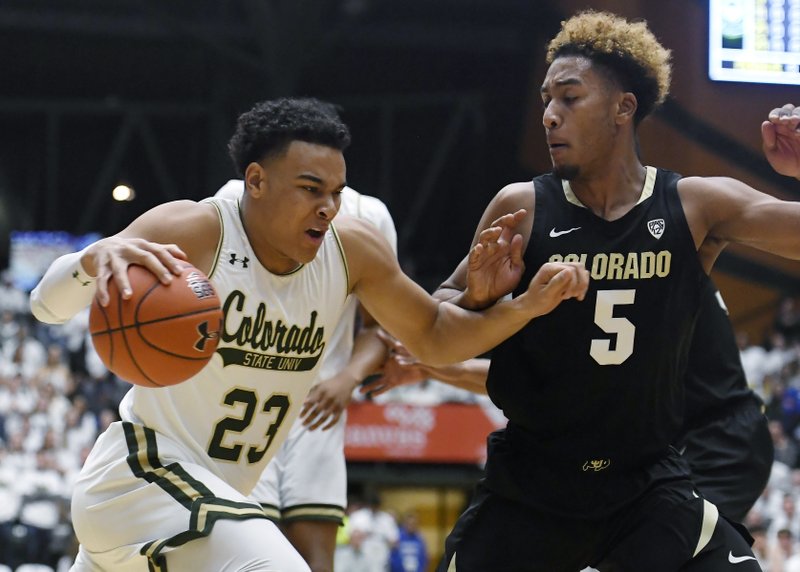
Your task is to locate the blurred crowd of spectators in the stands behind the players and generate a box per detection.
[0,273,800,572]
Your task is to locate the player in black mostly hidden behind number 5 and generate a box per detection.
[376,281,775,522]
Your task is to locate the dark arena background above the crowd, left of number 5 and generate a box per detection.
[0,0,559,285]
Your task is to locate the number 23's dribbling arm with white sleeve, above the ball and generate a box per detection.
[31,201,220,323]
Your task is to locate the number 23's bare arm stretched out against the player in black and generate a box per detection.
[338,214,588,365]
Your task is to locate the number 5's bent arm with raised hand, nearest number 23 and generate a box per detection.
[434,182,535,309]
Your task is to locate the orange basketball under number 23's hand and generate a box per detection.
[89,265,222,387]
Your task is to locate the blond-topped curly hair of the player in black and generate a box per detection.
[546,10,672,124]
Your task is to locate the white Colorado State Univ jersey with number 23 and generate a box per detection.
[120,198,348,494]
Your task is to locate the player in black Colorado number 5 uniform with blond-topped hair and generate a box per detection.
[418,12,800,572]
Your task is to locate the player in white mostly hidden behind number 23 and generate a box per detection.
[215,179,397,572]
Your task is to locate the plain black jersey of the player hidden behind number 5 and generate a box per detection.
[684,280,758,430]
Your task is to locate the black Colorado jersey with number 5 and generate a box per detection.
[487,167,708,479]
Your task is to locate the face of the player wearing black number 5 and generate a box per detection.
[541,56,616,180]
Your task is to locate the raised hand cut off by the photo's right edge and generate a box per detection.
[761,103,800,178]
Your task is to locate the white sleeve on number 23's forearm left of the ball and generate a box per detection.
[30,252,95,324]
